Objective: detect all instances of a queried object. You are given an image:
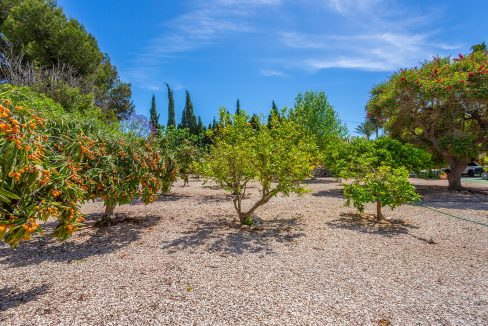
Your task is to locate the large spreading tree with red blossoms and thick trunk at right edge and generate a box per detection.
[368,49,488,190]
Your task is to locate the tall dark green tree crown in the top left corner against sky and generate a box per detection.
[0,0,134,120]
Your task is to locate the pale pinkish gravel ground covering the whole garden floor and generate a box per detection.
[0,178,488,325]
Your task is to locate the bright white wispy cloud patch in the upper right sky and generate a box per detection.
[281,0,463,71]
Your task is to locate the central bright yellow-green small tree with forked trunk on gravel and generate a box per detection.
[199,110,317,225]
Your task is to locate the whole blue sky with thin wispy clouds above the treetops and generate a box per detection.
[58,0,488,131]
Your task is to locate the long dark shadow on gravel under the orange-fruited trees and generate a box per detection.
[0,214,160,268]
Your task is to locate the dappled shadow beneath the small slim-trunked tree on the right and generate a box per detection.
[326,213,420,241]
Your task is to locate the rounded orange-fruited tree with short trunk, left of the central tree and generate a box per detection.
[82,137,176,216]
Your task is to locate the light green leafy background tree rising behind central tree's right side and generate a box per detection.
[290,91,348,151]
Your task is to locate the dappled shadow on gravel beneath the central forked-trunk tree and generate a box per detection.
[161,219,305,255]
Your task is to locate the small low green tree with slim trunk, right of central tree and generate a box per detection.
[326,138,430,220]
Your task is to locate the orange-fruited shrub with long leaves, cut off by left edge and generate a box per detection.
[0,99,83,246]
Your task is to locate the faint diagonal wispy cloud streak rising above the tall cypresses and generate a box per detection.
[127,0,282,90]
